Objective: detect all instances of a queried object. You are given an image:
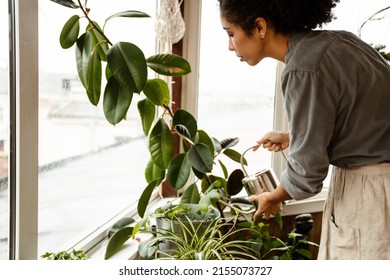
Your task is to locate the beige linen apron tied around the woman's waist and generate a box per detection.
[318,163,390,260]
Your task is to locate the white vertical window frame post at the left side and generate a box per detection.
[9,0,38,260]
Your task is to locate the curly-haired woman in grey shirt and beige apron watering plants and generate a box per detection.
[219,0,390,259]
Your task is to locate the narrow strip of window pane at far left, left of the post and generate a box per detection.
[0,0,10,260]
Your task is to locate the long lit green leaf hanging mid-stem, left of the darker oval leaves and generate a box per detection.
[149,119,173,169]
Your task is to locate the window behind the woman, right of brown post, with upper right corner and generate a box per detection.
[198,0,390,201]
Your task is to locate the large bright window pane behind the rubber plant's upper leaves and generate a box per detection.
[39,0,156,254]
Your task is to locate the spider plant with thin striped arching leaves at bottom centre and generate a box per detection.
[139,216,259,260]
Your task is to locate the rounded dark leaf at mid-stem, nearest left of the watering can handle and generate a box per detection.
[188,143,213,173]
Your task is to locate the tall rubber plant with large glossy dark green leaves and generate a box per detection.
[51,0,247,258]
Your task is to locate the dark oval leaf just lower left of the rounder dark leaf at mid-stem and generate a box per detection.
[167,153,191,190]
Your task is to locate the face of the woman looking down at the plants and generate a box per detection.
[221,16,264,66]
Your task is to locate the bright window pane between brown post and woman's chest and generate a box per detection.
[198,1,276,177]
